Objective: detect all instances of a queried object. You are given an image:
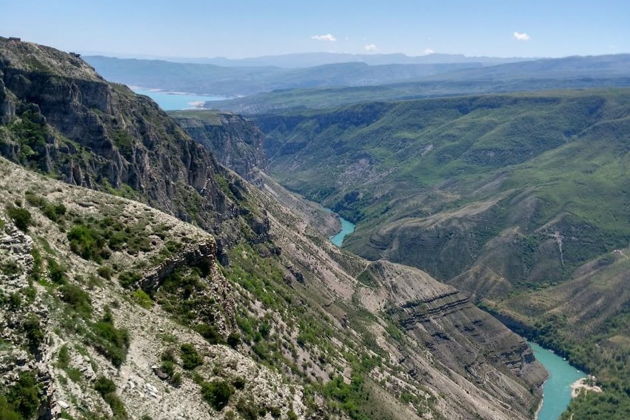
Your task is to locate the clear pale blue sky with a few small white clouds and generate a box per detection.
[0,0,630,58]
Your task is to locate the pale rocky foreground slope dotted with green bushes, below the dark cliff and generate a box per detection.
[0,158,305,419]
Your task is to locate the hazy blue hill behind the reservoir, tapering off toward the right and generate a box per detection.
[85,56,482,96]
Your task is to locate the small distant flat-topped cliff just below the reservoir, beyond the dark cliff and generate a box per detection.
[169,111,267,183]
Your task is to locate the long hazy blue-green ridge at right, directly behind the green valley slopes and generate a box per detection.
[207,54,630,114]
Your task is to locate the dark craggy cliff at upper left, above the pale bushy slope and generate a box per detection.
[0,38,266,249]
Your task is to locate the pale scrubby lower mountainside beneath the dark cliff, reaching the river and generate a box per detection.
[0,160,543,419]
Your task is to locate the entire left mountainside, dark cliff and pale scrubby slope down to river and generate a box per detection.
[0,39,544,419]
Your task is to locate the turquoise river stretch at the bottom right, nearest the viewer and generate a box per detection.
[529,342,586,420]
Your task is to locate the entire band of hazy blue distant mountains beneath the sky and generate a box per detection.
[84,53,630,105]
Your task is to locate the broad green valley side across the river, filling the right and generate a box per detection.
[257,90,630,418]
